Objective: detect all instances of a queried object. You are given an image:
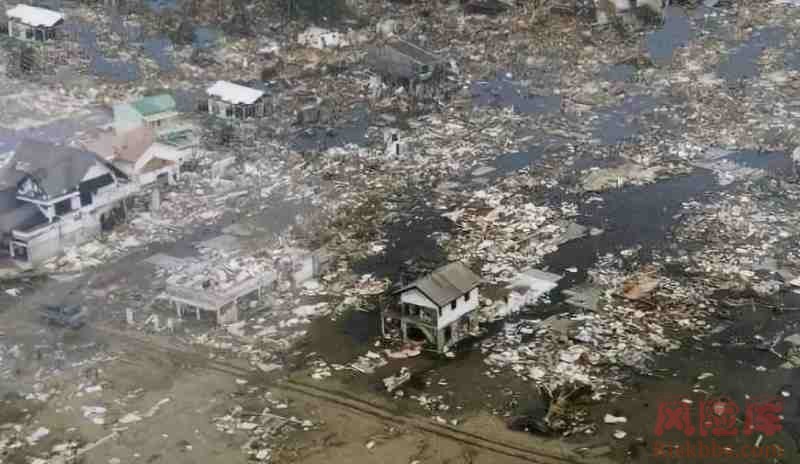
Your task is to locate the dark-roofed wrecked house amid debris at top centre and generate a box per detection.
[367,39,447,97]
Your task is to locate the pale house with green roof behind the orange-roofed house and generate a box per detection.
[113,94,180,135]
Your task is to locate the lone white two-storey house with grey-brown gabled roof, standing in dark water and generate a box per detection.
[384,262,480,352]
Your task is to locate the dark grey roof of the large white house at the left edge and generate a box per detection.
[11,139,105,198]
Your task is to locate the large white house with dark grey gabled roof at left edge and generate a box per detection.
[0,140,136,265]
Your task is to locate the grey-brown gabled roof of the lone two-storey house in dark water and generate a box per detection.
[395,262,481,308]
